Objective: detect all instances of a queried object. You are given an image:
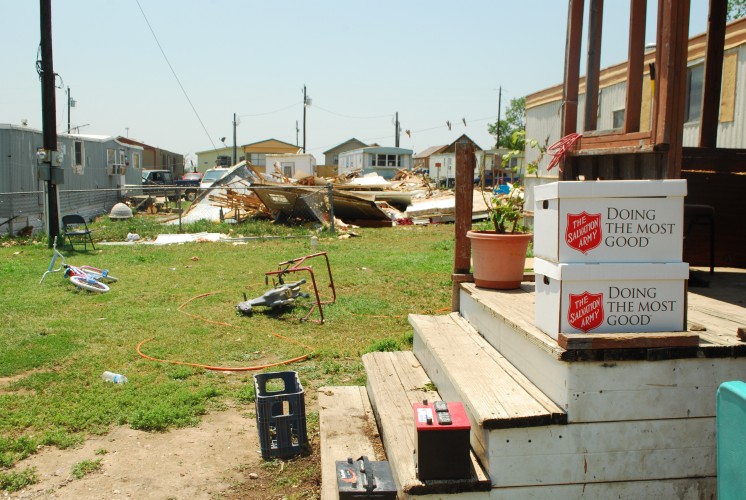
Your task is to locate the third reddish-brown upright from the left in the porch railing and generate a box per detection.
[624,0,649,133]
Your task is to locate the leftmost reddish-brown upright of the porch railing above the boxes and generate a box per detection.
[561,0,584,137]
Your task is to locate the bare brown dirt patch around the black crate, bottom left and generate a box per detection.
[5,409,320,500]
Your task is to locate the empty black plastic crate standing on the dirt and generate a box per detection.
[254,372,308,458]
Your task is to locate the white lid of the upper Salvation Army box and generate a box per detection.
[534,179,686,200]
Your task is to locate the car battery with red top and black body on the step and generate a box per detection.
[413,401,472,481]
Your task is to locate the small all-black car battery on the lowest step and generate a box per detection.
[335,456,396,500]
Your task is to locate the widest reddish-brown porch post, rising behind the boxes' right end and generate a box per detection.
[653,0,690,179]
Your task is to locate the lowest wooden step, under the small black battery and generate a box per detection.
[318,386,386,500]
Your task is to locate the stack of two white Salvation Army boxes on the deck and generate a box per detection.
[534,180,689,339]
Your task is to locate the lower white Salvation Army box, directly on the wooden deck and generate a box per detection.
[534,259,689,339]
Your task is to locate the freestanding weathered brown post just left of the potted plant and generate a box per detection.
[453,137,476,274]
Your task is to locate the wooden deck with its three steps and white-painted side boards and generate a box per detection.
[319,268,746,500]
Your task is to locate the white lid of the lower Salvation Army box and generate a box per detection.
[534,258,689,281]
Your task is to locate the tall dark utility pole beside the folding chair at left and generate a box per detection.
[39,0,64,248]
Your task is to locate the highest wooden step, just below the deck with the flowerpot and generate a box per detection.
[409,313,567,469]
